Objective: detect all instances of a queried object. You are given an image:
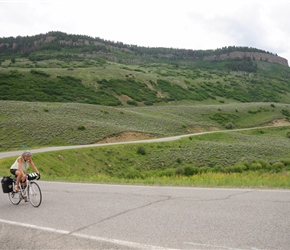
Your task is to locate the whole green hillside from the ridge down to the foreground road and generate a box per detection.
[0,32,290,188]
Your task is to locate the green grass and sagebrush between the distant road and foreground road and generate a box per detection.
[0,126,290,188]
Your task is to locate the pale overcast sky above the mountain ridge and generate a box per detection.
[0,0,290,63]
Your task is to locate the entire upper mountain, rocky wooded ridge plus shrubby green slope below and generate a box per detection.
[0,32,290,106]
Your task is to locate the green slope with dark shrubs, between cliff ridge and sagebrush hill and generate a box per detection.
[0,58,290,106]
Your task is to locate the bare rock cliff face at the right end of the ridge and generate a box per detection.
[204,51,288,66]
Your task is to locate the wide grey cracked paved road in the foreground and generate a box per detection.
[0,181,290,250]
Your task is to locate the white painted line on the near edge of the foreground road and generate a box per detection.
[0,219,176,250]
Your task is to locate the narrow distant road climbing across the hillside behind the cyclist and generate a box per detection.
[0,124,289,159]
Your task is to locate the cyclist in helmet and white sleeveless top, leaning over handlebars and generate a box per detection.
[10,151,40,192]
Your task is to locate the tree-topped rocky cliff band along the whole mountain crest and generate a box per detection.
[0,32,288,66]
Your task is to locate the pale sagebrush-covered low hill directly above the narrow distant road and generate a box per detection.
[0,101,290,151]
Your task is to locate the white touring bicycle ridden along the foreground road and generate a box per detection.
[8,173,42,207]
